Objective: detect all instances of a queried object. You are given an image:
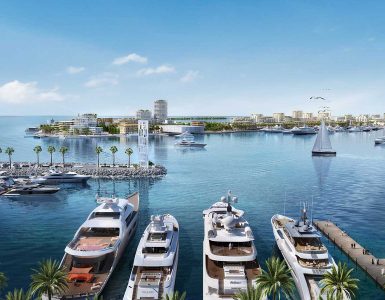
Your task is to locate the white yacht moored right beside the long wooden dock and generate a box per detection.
[271,206,335,300]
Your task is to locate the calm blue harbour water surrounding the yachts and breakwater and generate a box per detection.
[0,117,385,300]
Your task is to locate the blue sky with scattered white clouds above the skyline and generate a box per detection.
[0,0,385,116]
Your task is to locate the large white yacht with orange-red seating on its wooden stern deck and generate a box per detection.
[57,193,139,299]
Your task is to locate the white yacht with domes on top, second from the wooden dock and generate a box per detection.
[203,191,261,300]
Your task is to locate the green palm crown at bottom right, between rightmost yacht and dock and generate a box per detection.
[321,262,359,299]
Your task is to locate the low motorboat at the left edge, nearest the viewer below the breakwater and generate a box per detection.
[0,176,60,198]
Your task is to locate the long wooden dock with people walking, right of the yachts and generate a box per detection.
[314,221,385,288]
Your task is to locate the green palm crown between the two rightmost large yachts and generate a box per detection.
[256,257,294,300]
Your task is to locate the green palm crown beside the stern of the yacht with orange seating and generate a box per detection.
[31,259,68,300]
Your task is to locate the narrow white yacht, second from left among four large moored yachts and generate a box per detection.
[123,215,179,300]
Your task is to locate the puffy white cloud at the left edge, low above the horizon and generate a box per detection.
[0,80,64,104]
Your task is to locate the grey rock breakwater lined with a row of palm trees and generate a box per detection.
[0,163,167,179]
